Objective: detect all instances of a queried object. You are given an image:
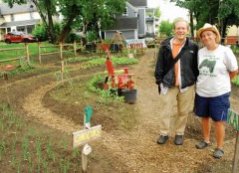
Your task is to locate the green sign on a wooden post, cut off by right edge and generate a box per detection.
[227,109,239,173]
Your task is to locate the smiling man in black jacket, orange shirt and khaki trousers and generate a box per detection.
[155,18,198,145]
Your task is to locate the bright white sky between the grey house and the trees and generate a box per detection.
[148,0,189,22]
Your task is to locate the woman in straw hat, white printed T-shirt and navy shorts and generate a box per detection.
[195,23,238,159]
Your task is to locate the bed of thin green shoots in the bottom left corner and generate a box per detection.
[0,103,88,173]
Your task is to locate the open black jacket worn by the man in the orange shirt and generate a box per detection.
[154,38,198,88]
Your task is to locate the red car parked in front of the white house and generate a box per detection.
[4,32,37,44]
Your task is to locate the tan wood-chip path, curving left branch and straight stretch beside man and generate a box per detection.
[23,50,238,173]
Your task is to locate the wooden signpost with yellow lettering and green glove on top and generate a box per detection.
[72,106,102,173]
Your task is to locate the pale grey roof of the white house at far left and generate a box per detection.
[0,3,37,15]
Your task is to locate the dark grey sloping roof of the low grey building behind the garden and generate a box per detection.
[107,17,138,30]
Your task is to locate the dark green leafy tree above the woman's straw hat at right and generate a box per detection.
[176,0,239,41]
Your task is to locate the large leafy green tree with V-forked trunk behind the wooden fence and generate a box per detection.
[4,0,126,42]
